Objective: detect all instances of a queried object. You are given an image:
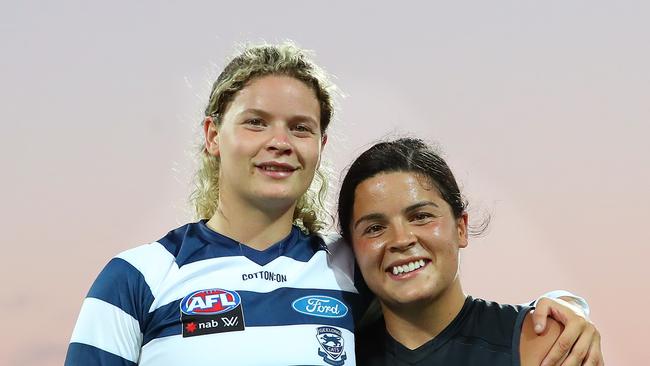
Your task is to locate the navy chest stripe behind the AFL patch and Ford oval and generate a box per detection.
[142,288,365,346]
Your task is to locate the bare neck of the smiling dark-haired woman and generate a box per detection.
[380,278,466,349]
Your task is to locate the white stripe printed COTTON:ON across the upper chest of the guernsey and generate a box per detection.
[117,236,357,312]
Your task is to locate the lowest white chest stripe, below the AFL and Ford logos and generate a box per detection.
[140,324,355,366]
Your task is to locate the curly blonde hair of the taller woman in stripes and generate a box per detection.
[190,42,336,234]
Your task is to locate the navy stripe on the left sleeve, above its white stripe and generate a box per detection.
[88,258,154,330]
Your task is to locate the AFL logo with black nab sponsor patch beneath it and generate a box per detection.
[180,288,244,337]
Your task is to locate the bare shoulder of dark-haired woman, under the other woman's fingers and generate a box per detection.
[519,310,563,366]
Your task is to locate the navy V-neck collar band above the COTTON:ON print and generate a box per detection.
[158,220,325,268]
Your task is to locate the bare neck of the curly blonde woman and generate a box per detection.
[206,193,295,250]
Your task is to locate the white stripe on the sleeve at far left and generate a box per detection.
[70,297,142,362]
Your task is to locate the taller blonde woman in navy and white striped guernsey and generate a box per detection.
[66,44,596,365]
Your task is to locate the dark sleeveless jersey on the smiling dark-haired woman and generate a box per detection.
[357,296,531,366]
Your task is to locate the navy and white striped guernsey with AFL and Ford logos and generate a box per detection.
[65,221,365,366]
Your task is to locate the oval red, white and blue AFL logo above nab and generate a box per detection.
[181,288,241,315]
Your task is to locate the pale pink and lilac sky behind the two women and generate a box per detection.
[0,0,650,365]
